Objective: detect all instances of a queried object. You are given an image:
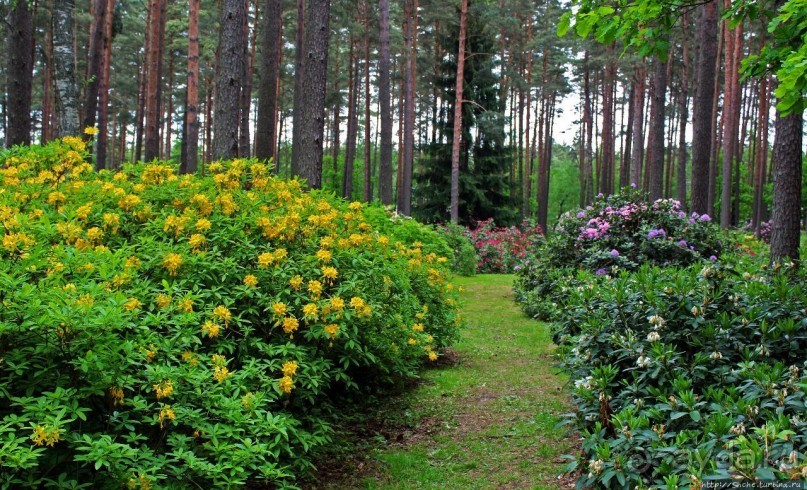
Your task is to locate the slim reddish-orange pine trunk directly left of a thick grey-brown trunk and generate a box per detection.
[179,0,200,174]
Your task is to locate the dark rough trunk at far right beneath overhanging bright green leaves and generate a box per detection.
[771,106,804,262]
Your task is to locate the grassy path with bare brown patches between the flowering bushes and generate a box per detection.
[304,275,576,489]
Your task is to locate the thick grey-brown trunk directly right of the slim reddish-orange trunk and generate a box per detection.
[213,0,247,159]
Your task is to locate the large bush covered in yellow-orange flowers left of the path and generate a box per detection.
[0,138,460,488]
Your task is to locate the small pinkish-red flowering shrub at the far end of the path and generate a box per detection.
[467,219,543,274]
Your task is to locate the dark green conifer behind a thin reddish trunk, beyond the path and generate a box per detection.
[414,0,516,225]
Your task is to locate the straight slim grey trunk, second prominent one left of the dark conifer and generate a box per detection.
[378,0,392,204]
